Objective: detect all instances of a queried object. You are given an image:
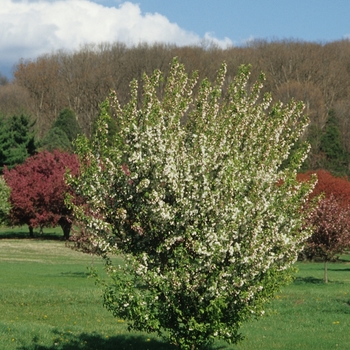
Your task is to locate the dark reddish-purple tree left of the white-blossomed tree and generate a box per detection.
[4,151,79,239]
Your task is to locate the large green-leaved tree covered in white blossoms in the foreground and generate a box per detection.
[68,59,312,349]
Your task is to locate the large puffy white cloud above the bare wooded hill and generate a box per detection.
[0,0,231,67]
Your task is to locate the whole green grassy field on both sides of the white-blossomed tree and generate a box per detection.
[0,229,350,350]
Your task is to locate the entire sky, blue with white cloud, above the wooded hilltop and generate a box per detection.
[0,0,350,76]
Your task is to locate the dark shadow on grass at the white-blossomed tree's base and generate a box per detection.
[17,330,225,350]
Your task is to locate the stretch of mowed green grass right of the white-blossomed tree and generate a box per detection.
[236,256,350,350]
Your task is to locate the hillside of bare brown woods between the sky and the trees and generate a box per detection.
[0,40,350,174]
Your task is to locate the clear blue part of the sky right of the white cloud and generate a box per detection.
[123,0,350,44]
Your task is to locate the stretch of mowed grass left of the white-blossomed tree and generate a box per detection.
[0,230,172,350]
